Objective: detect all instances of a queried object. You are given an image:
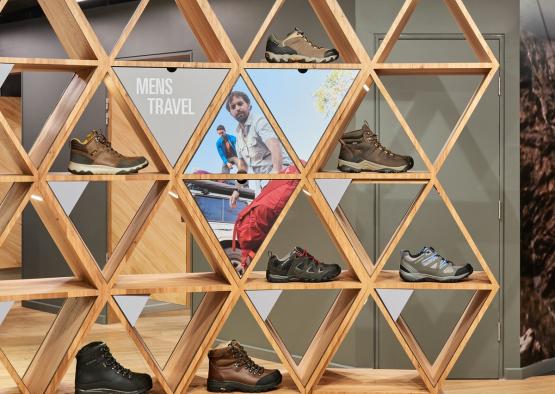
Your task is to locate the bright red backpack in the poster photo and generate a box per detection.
[232,165,299,269]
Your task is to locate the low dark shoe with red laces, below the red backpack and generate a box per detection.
[266,246,341,283]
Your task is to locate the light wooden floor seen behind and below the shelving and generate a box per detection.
[0,305,555,394]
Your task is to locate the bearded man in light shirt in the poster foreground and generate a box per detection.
[226,91,291,208]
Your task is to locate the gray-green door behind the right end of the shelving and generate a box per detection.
[376,34,503,378]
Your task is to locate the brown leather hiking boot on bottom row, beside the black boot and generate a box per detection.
[207,340,281,393]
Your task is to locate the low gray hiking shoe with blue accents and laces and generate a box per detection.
[399,246,473,282]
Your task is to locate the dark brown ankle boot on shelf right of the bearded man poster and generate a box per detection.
[337,121,414,172]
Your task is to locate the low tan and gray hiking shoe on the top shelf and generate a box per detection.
[265,28,339,63]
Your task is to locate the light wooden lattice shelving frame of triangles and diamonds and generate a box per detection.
[0,0,499,393]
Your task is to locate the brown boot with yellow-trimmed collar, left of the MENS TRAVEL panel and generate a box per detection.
[68,130,148,175]
